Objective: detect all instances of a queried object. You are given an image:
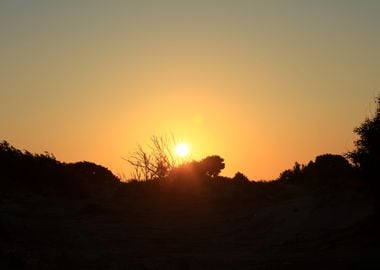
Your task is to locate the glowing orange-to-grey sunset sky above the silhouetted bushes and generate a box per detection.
[0,0,380,180]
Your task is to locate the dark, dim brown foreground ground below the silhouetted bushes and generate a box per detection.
[0,180,380,269]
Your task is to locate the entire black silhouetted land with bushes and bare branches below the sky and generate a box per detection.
[0,98,380,269]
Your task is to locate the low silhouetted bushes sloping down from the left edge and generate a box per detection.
[0,141,119,197]
